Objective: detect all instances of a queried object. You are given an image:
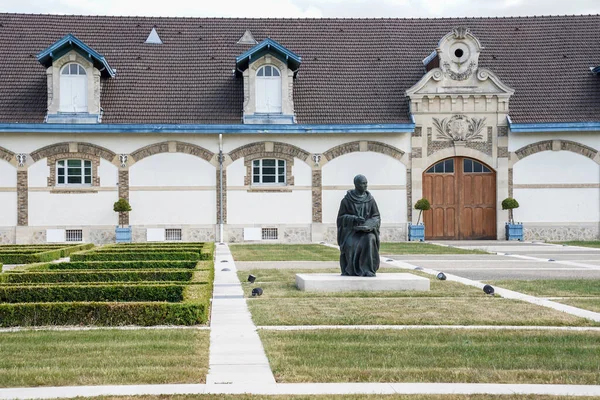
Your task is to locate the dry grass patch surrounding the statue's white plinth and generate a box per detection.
[238,268,595,326]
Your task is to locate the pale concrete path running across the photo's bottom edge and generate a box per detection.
[0,383,600,400]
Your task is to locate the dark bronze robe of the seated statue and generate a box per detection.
[337,190,381,276]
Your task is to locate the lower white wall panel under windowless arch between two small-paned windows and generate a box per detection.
[129,190,217,225]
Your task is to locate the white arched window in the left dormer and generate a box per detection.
[60,63,87,112]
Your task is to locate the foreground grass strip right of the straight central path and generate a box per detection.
[260,330,600,385]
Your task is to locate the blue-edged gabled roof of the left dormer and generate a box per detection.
[37,33,117,78]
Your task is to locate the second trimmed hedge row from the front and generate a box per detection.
[0,284,185,303]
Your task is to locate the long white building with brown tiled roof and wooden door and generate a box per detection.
[0,14,600,243]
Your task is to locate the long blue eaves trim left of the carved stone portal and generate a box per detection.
[0,123,415,135]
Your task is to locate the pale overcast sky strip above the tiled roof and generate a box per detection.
[0,0,600,18]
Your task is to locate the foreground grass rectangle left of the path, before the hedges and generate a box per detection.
[0,329,209,387]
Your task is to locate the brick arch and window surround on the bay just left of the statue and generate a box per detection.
[229,141,310,186]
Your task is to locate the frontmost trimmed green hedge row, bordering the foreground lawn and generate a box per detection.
[0,302,209,327]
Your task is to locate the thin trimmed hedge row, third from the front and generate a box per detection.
[0,269,194,283]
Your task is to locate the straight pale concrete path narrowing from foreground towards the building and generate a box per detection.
[206,244,275,385]
